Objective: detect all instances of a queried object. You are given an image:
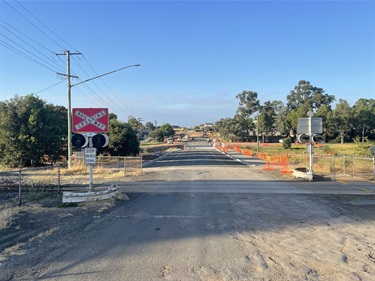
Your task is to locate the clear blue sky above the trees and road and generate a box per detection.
[0,0,375,126]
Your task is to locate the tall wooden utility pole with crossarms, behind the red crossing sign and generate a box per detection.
[56,50,82,169]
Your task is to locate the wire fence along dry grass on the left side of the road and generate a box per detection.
[0,156,143,204]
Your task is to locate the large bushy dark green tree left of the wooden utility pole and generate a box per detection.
[0,95,67,167]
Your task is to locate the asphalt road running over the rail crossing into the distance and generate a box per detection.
[24,143,375,281]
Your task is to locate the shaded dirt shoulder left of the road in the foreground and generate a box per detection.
[0,192,129,281]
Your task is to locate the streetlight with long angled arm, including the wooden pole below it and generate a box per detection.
[67,63,141,169]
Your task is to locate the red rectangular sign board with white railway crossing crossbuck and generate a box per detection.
[72,108,108,133]
